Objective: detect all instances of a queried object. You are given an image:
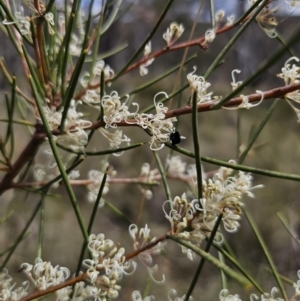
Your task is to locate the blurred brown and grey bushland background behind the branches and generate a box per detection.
[0,0,300,300]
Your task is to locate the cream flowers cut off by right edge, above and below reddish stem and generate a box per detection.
[277,56,300,122]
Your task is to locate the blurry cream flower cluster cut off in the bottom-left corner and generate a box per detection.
[0,269,29,301]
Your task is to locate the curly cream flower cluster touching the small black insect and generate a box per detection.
[134,92,177,151]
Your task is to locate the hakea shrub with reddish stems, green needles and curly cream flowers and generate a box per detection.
[0,0,300,301]
